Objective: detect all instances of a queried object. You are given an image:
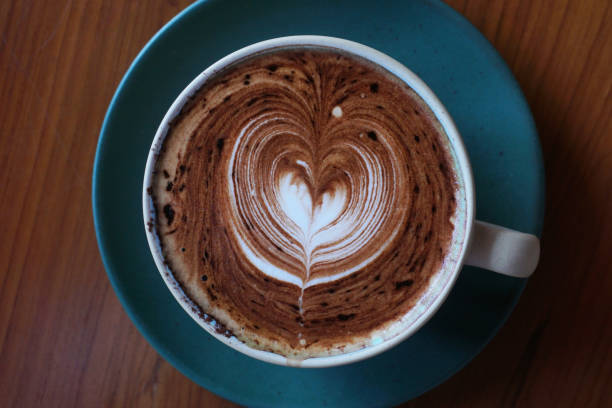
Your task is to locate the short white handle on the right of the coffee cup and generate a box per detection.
[465,220,540,278]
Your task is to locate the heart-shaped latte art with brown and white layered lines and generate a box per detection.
[227,101,409,288]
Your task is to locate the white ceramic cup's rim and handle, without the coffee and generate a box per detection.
[143,35,540,367]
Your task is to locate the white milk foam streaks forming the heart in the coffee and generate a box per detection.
[227,109,400,290]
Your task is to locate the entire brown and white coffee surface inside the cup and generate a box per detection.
[152,49,457,358]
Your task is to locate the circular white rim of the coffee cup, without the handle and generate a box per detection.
[142,35,476,368]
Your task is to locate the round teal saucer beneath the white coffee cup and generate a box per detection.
[93,0,544,407]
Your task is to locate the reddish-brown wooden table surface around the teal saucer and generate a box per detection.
[0,0,612,407]
